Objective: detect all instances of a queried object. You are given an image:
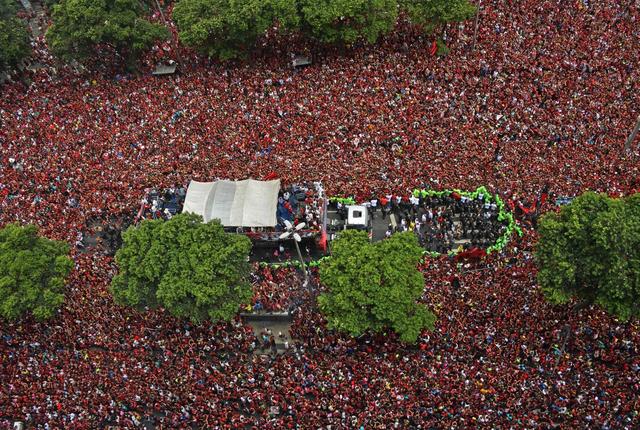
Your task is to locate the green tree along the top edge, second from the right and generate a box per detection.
[298,0,398,45]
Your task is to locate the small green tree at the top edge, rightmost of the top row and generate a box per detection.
[401,0,477,33]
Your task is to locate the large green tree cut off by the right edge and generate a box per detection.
[536,192,640,320]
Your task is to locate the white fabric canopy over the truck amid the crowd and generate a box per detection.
[182,179,280,227]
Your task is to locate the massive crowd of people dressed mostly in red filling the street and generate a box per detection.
[0,0,640,429]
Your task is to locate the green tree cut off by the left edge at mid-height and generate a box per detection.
[0,224,73,321]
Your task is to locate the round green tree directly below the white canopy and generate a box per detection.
[111,214,252,323]
